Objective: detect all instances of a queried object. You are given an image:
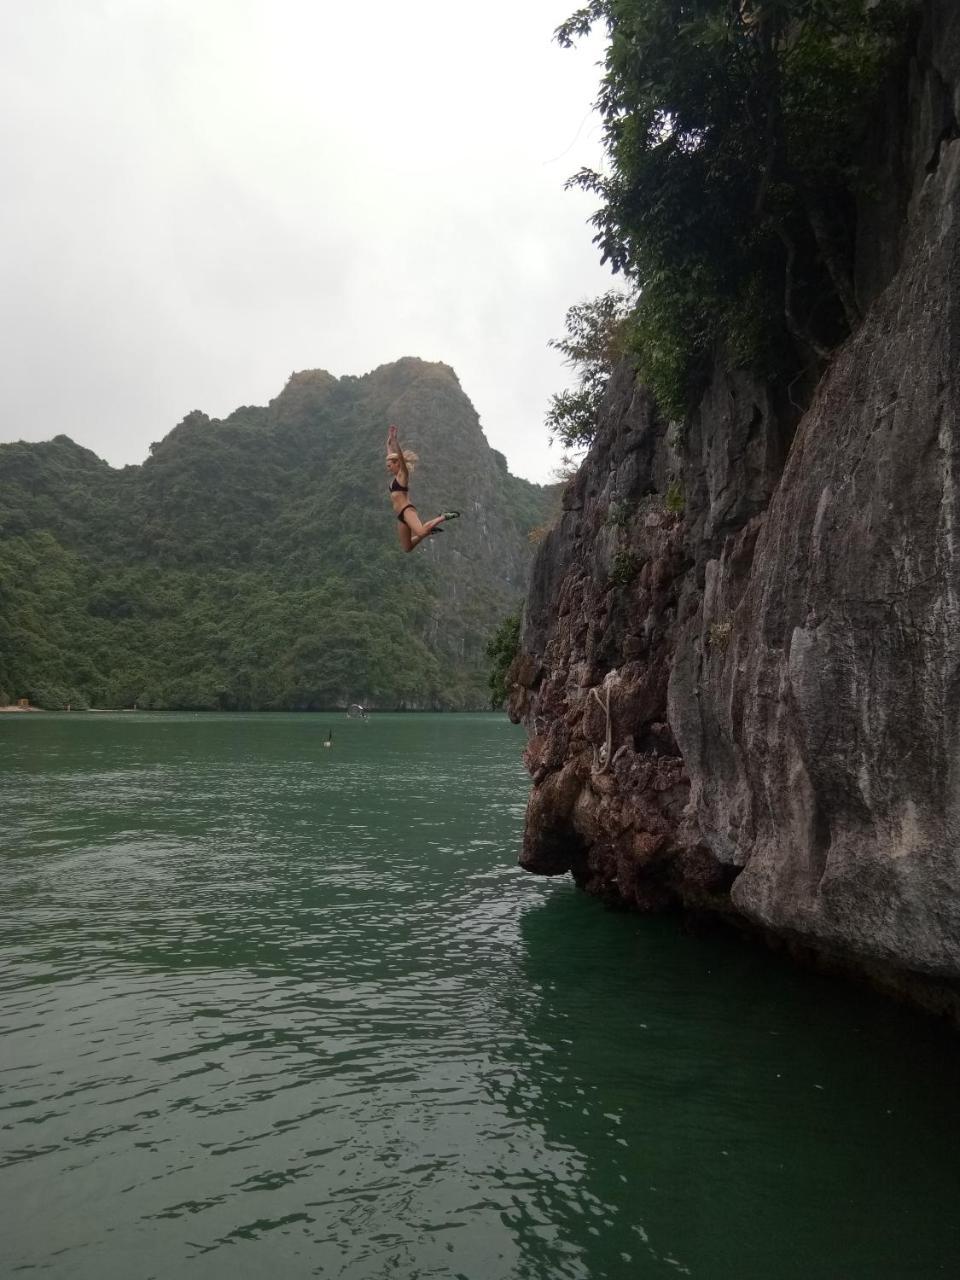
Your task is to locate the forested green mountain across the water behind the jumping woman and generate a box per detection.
[0,358,554,709]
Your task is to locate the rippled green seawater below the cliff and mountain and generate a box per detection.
[0,714,960,1280]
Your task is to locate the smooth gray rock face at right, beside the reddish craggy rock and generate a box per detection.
[671,124,960,974]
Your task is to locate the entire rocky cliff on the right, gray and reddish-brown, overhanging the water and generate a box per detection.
[511,0,960,1010]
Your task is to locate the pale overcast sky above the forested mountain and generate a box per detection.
[0,0,614,480]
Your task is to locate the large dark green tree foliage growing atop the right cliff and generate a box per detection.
[557,0,911,415]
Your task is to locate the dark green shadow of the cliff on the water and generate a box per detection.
[495,891,960,1280]
